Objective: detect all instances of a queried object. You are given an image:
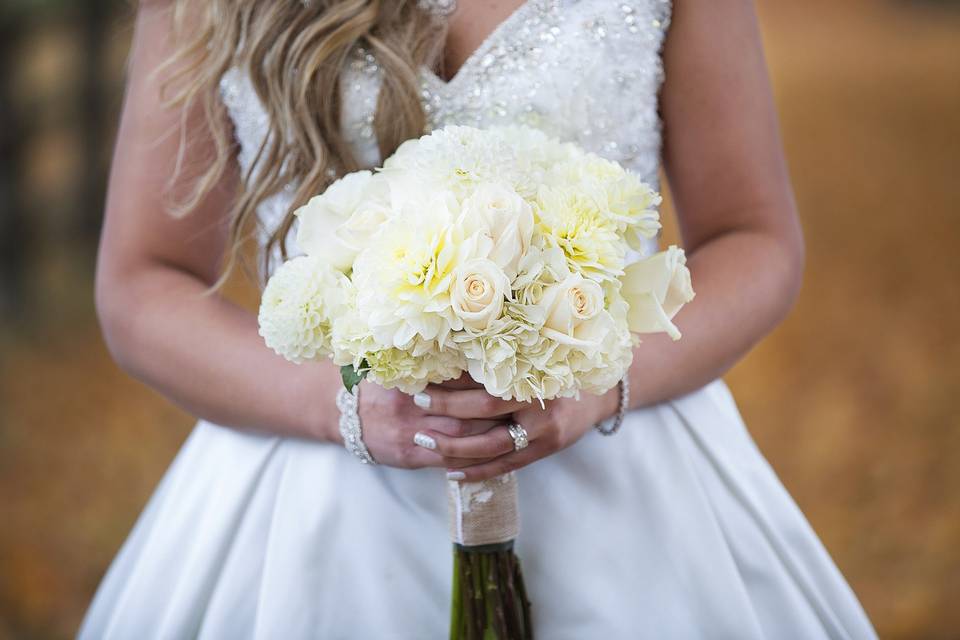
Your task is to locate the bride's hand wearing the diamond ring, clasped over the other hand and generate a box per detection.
[420,386,619,482]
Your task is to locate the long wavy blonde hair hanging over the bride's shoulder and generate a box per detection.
[161,0,445,285]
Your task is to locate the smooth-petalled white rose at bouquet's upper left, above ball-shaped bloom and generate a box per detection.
[295,171,374,271]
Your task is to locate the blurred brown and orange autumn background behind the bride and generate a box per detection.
[0,0,960,639]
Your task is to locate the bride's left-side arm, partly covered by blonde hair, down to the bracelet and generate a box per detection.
[96,2,339,439]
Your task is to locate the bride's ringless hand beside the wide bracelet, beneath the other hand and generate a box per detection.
[359,382,520,469]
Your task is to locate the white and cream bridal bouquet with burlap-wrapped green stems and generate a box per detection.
[259,127,693,638]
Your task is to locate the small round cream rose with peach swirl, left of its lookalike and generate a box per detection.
[450,258,510,331]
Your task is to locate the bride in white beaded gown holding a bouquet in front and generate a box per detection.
[80,0,875,640]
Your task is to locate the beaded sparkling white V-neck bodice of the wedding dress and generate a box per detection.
[221,0,671,270]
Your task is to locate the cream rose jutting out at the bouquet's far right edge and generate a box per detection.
[622,246,694,340]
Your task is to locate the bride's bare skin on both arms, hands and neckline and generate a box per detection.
[96,0,803,481]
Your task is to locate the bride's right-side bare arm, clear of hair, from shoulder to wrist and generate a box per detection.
[630,0,803,406]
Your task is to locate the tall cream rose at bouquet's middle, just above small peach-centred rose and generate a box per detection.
[461,183,533,280]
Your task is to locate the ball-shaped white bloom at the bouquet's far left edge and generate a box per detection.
[257,256,350,363]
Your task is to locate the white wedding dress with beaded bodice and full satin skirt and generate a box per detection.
[80,0,875,640]
